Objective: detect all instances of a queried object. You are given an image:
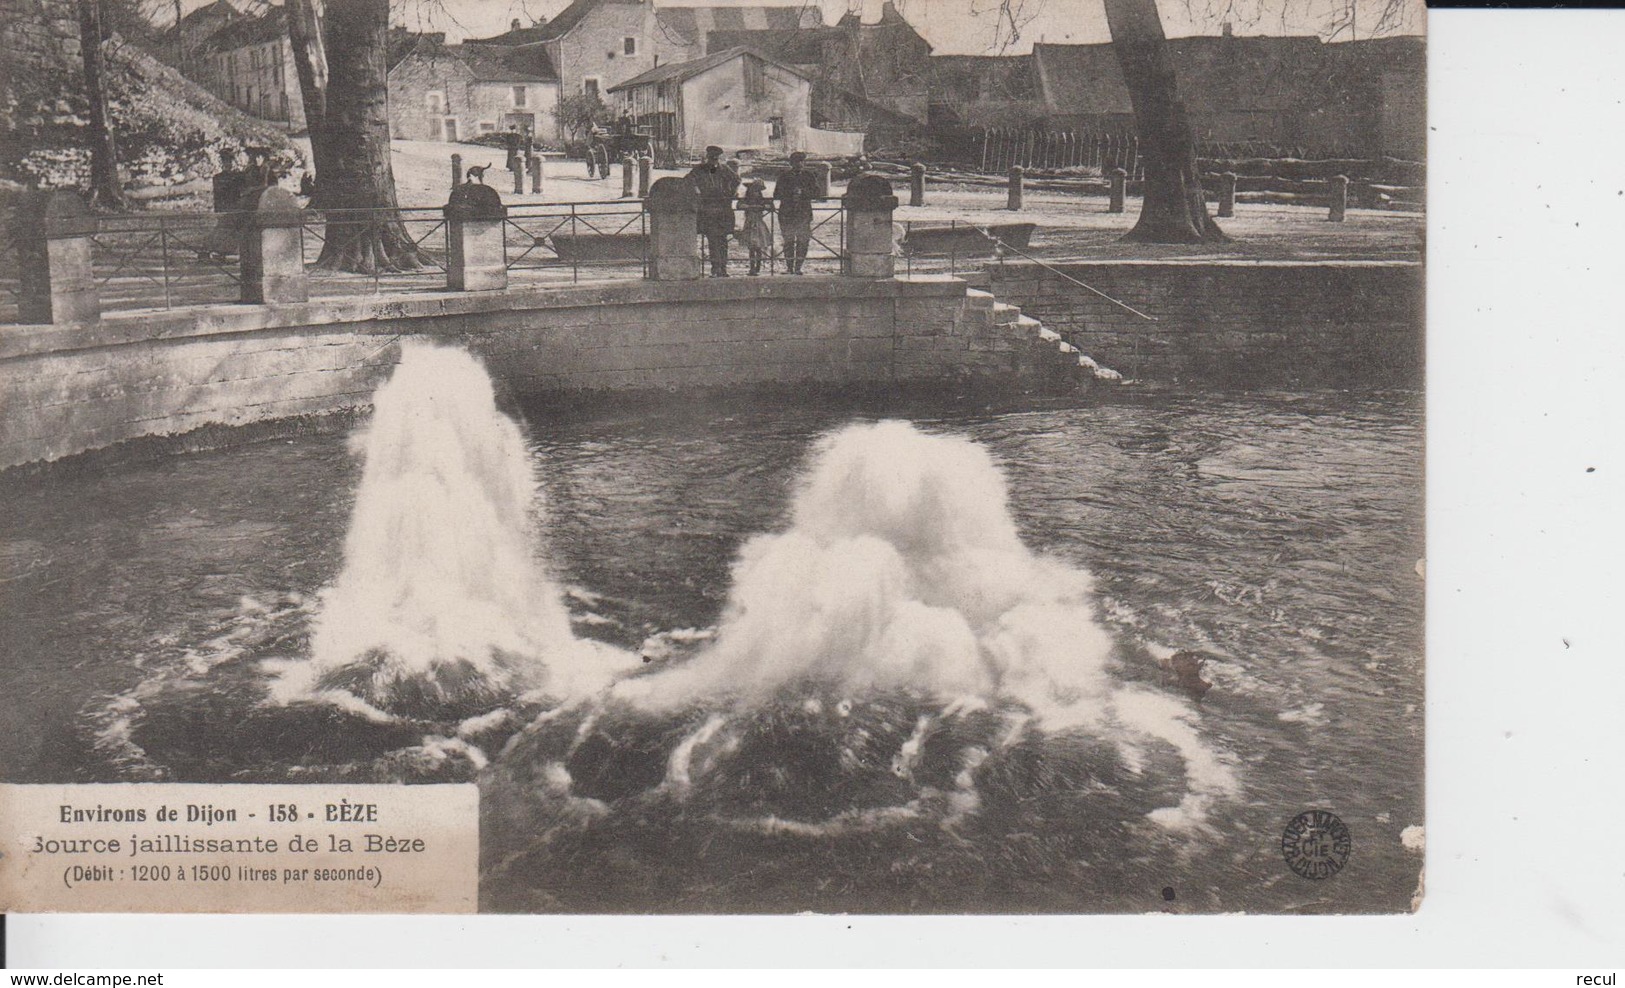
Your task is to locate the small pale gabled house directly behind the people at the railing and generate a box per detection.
[609,47,863,156]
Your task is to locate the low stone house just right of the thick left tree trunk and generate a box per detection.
[388,34,559,141]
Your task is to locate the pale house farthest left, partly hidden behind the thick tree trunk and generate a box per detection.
[187,5,306,132]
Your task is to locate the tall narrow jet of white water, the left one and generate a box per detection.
[280,343,631,702]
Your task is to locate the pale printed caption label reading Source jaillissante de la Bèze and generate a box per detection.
[0,783,479,913]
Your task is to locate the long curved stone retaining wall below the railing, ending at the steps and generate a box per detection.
[0,271,1092,470]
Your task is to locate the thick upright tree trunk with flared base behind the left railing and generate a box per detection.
[312,0,423,275]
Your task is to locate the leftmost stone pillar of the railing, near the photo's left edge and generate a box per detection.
[10,192,101,325]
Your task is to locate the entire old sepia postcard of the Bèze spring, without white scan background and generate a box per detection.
[0,0,1427,913]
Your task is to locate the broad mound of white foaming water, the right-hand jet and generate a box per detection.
[611,421,1235,826]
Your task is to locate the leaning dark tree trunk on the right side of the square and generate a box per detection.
[1105,0,1230,244]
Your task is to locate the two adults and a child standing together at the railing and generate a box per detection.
[687,145,819,278]
